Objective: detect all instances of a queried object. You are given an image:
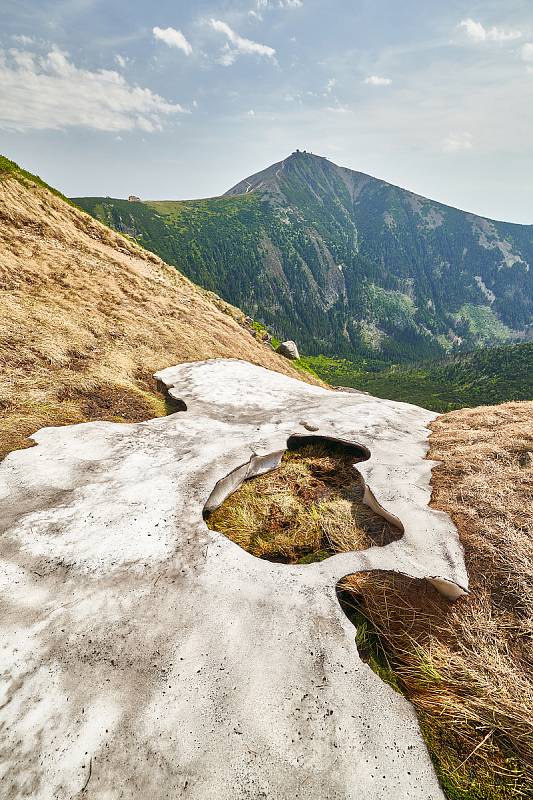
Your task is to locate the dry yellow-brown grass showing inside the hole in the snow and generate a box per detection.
[207,441,401,564]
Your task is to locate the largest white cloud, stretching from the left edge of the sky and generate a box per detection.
[0,50,184,132]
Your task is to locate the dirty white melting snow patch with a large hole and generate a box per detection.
[0,360,467,800]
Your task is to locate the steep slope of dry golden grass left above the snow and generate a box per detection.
[0,159,316,457]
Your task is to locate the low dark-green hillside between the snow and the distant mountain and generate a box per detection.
[302,342,533,412]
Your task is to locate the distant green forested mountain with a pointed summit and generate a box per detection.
[76,152,533,359]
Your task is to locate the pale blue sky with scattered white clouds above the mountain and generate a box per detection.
[0,0,533,224]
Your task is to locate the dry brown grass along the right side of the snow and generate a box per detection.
[340,403,533,800]
